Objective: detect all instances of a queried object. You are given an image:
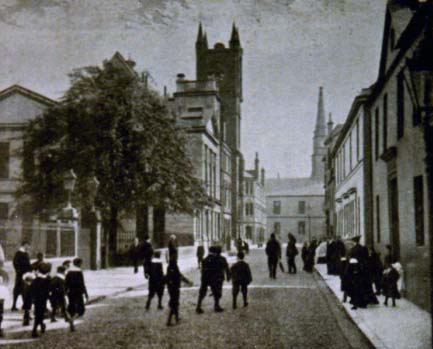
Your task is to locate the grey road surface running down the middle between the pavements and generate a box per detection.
[4,250,371,348]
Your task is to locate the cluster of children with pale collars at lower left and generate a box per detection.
[0,255,88,337]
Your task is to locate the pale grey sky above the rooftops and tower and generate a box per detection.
[0,0,386,177]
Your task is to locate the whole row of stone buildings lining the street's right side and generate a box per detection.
[324,0,433,309]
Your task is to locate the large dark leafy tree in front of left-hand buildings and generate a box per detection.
[19,55,206,264]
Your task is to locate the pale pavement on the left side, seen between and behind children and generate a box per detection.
[0,247,197,334]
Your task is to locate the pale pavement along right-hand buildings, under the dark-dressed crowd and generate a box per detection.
[315,264,432,349]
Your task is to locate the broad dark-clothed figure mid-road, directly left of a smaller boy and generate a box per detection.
[196,246,230,314]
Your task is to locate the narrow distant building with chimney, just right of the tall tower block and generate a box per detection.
[242,153,266,244]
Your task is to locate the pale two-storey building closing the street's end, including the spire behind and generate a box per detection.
[265,87,327,241]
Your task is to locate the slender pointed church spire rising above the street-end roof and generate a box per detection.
[311,86,327,181]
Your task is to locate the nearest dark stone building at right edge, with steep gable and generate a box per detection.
[367,0,433,309]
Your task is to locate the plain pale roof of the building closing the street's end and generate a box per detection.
[265,177,325,196]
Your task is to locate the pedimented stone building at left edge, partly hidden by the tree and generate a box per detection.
[0,85,56,258]
